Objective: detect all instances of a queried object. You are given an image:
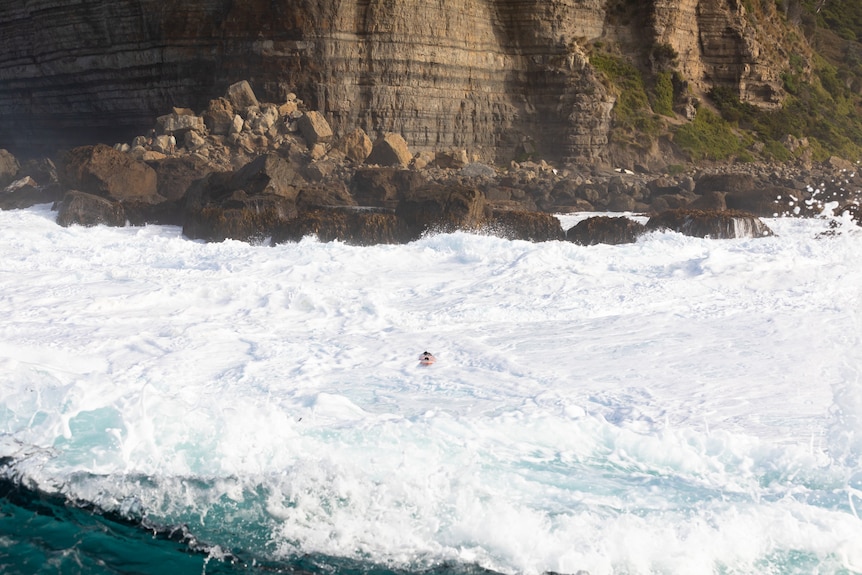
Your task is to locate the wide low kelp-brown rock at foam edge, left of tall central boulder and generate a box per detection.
[272,207,406,246]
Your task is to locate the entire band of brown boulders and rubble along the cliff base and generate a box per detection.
[0,81,862,245]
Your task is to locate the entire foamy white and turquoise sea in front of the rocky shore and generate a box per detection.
[0,206,862,575]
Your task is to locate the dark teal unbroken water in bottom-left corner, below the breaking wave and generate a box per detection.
[0,479,502,575]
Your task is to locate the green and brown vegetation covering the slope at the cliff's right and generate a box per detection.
[590,0,862,162]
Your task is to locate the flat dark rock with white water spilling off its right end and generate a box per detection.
[646,209,772,239]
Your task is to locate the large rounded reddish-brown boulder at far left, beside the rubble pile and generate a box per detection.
[60,144,164,203]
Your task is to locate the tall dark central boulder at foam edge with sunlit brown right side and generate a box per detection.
[395,184,486,239]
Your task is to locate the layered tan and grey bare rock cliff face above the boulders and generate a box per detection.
[0,0,781,162]
